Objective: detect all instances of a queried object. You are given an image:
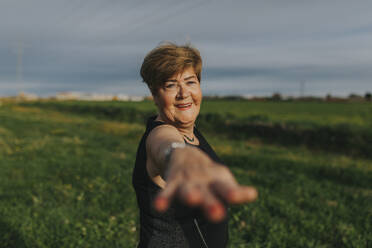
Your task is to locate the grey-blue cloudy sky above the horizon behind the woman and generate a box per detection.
[0,0,372,96]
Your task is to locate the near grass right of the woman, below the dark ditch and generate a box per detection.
[211,139,372,247]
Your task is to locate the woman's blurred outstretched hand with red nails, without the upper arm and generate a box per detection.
[154,148,258,222]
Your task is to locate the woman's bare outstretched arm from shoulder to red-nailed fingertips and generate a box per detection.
[147,126,257,222]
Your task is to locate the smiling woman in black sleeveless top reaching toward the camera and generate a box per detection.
[133,43,257,248]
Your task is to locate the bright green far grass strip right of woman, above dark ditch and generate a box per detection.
[202,100,372,127]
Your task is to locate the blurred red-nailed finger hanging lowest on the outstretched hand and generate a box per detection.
[202,189,226,222]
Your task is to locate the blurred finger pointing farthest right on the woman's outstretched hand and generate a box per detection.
[211,181,258,204]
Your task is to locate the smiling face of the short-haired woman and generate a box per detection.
[154,67,202,127]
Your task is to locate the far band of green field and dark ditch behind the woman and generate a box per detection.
[23,100,372,158]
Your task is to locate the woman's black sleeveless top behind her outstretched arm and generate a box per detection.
[132,116,228,248]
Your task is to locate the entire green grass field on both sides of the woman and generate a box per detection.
[0,101,372,248]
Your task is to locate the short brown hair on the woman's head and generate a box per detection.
[141,42,202,95]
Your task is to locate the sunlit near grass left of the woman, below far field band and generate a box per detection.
[0,106,143,247]
